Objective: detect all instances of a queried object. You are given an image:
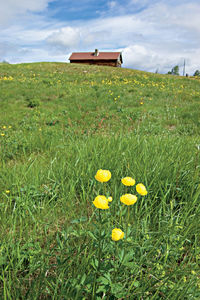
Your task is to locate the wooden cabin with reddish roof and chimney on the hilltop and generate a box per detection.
[69,49,123,67]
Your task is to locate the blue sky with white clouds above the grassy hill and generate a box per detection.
[0,0,200,75]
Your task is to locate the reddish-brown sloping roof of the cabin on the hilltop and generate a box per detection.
[69,52,122,61]
